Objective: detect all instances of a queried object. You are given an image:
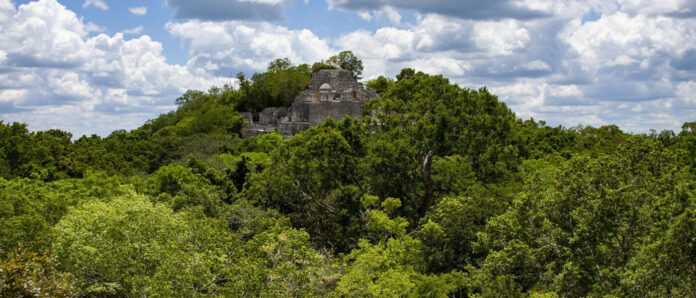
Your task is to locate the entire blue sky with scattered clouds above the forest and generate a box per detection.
[0,0,696,137]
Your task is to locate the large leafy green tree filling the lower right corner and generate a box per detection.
[470,136,693,296]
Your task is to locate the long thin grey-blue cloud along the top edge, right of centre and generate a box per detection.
[327,0,547,20]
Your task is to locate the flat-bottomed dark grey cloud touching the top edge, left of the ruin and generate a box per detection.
[166,0,292,21]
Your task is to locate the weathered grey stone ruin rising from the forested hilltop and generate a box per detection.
[240,69,379,138]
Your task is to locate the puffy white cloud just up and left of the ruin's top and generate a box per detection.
[165,21,336,76]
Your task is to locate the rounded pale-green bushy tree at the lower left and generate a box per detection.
[54,192,244,296]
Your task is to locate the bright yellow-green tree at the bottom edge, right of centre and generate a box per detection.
[334,195,466,297]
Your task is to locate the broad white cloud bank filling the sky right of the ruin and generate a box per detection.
[334,4,696,132]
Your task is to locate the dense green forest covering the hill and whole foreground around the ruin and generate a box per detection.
[0,52,696,297]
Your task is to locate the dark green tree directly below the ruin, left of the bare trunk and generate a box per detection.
[241,117,367,252]
